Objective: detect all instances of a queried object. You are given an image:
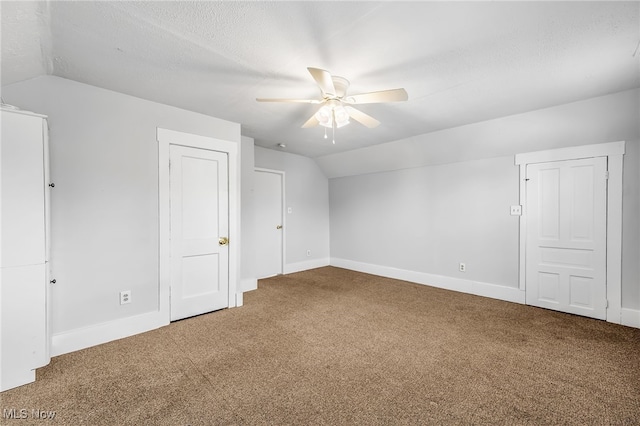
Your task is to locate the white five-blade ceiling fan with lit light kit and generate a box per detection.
[256,67,409,143]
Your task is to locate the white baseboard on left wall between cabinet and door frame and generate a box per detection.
[51,311,169,356]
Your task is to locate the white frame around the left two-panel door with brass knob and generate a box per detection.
[156,127,242,324]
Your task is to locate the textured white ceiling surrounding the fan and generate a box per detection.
[0,1,640,157]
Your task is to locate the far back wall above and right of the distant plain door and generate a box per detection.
[255,146,329,273]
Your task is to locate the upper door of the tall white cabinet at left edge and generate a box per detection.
[0,111,45,267]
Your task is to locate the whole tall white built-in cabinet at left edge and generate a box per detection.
[0,108,50,391]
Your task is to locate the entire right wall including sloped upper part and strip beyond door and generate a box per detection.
[324,89,640,320]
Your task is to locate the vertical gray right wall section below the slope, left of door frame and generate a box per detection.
[329,157,518,287]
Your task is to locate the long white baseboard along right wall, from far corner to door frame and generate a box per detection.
[331,257,525,304]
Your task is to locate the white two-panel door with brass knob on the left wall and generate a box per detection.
[169,145,229,321]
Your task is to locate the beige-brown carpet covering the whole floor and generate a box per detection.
[0,267,640,426]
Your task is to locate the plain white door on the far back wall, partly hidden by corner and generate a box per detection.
[254,170,283,278]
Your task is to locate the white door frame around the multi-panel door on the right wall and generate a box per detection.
[515,141,625,324]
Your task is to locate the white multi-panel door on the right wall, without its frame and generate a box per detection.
[526,157,607,319]
